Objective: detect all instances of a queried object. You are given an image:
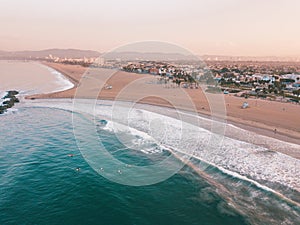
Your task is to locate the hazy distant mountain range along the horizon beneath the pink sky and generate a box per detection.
[0,49,300,62]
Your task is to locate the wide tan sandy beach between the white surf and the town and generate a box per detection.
[27,62,300,151]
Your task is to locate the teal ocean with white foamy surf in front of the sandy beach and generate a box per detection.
[0,60,300,225]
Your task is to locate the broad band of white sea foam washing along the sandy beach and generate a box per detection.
[22,100,300,191]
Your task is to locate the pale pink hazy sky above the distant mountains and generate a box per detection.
[0,0,300,57]
